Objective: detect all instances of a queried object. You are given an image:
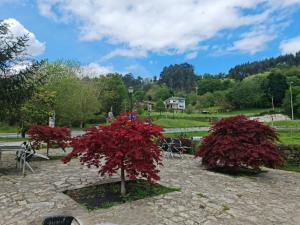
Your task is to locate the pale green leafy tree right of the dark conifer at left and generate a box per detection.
[42,62,100,127]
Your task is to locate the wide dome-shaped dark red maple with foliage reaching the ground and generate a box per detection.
[196,116,283,170]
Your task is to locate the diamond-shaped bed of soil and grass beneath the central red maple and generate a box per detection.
[64,180,180,210]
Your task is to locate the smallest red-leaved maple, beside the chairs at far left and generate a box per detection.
[28,125,71,156]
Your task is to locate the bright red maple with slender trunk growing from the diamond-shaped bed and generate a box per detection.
[63,113,163,195]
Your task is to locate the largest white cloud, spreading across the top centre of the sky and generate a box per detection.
[38,0,299,58]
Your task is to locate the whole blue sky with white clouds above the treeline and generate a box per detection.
[0,0,300,77]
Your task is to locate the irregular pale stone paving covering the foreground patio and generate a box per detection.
[0,149,300,225]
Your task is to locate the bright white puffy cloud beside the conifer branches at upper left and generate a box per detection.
[3,18,45,56]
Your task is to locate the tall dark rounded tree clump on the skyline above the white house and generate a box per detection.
[159,63,196,91]
